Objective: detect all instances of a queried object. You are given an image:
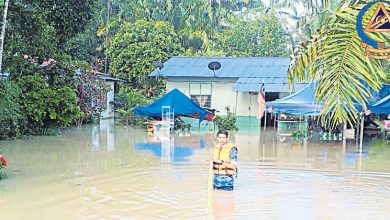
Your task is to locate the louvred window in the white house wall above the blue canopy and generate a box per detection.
[190,83,211,108]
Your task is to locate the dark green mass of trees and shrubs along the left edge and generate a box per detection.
[0,0,102,139]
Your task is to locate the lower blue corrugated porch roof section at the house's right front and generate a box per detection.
[233,77,307,92]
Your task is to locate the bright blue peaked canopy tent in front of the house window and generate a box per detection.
[134,89,208,121]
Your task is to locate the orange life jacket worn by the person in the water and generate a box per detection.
[213,144,237,176]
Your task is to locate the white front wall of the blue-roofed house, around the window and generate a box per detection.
[167,78,258,116]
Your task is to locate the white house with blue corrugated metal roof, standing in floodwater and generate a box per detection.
[149,56,304,117]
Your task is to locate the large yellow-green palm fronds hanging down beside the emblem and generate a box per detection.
[289,0,386,126]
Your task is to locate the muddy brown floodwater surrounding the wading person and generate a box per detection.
[0,121,390,220]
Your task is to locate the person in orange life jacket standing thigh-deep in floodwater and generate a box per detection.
[213,130,237,191]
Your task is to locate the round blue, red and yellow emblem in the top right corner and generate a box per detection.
[356,0,390,59]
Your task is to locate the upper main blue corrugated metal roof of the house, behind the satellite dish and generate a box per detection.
[149,57,290,78]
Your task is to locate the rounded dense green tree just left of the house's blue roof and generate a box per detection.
[107,20,183,92]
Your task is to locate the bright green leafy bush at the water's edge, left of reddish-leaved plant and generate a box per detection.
[18,75,80,134]
